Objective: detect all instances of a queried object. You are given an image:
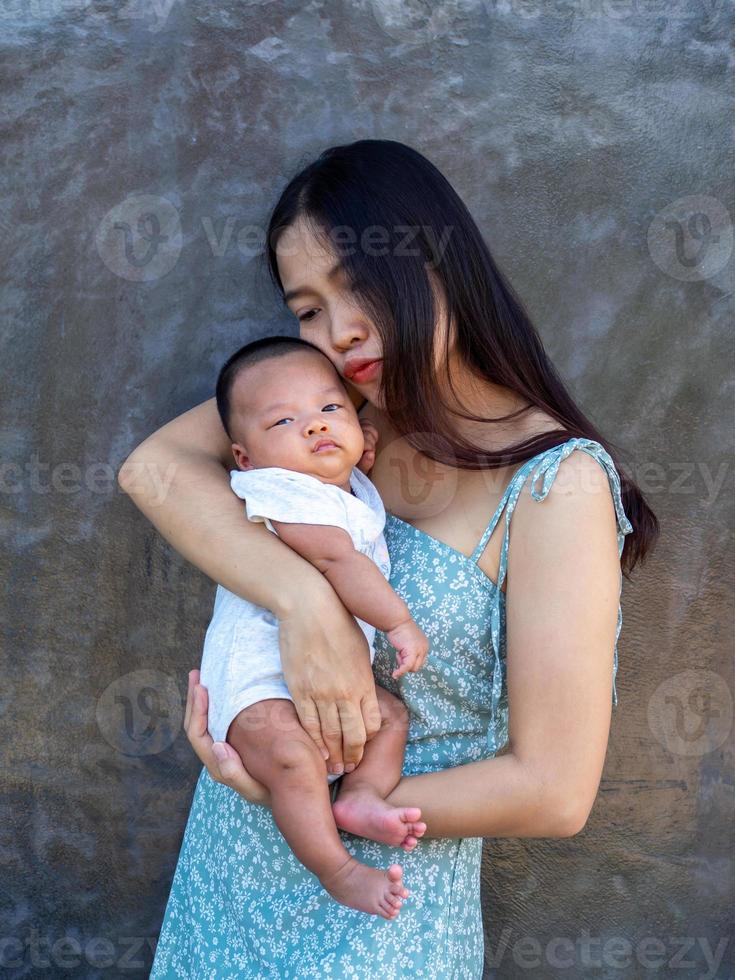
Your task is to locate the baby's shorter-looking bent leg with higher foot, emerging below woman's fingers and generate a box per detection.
[332,684,426,851]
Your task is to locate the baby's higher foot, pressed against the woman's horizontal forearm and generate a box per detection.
[332,785,426,851]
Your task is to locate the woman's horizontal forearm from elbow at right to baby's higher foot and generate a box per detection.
[388,752,584,837]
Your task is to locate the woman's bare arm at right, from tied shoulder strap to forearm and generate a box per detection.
[388,452,620,837]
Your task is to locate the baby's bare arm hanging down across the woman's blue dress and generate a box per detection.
[272,521,429,677]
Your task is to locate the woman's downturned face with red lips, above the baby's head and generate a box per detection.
[276,219,383,408]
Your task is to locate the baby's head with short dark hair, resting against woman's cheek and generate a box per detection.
[217,336,365,485]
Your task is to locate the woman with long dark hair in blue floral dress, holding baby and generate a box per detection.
[120,140,658,978]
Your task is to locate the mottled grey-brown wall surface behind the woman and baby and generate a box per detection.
[0,0,735,980]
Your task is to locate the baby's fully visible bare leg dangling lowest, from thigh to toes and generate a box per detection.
[227,698,408,919]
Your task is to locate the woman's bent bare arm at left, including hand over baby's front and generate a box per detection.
[118,398,380,765]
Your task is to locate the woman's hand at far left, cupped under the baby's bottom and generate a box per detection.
[184,670,271,807]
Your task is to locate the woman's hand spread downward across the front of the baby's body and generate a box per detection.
[278,582,381,773]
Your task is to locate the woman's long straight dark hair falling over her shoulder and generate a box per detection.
[267,134,659,576]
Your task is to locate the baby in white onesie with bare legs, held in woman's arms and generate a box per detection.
[201,337,429,919]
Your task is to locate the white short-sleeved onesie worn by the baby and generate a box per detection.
[196,466,390,782]
